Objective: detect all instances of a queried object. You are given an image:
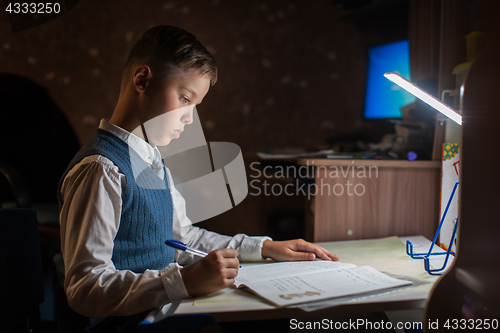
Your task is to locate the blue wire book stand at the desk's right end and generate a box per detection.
[406,182,459,275]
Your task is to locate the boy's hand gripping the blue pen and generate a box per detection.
[180,249,240,296]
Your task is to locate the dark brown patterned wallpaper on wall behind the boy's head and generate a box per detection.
[0,0,366,152]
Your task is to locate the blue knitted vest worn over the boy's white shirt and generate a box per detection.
[61,129,175,273]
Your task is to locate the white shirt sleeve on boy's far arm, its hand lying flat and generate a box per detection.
[167,169,272,265]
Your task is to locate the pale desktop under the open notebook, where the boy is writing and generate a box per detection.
[155,236,450,322]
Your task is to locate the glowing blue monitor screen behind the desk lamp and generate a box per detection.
[364,40,415,119]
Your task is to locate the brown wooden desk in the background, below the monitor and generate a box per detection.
[297,159,441,242]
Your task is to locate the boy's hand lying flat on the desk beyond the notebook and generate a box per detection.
[262,239,339,261]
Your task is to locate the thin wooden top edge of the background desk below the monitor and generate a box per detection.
[297,158,441,169]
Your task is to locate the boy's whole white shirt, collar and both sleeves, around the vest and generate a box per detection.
[60,119,271,317]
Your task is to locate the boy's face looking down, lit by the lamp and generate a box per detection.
[140,69,210,147]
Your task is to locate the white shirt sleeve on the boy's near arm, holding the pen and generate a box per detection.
[60,155,189,317]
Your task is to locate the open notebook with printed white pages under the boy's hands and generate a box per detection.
[235,260,412,307]
